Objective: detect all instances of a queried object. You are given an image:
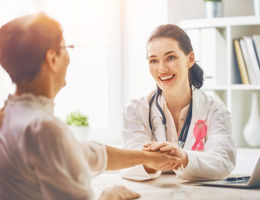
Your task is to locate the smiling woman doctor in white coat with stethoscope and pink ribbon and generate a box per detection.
[121,24,236,180]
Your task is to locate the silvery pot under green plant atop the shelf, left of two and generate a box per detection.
[205,1,223,18]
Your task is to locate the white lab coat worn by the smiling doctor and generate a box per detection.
[121,88,236,180]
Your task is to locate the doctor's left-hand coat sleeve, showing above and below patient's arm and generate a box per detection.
[121,100,161,180]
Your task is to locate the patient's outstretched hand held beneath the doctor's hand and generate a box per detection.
[144,151,181,173]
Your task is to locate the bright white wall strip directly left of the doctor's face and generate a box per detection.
[122,0,168,104]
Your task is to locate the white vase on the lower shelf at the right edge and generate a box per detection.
[244,92,260,147]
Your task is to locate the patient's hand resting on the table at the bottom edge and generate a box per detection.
[100,186,140,200]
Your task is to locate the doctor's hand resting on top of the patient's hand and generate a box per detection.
[143,142,188,168]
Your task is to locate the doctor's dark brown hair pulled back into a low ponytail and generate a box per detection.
[147,24,204,89]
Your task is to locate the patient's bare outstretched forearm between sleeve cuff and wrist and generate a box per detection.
[106,146,149,170]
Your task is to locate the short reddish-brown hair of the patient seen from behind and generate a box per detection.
[0,13,62,84]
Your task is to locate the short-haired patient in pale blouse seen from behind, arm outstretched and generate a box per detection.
[0,13,180,200]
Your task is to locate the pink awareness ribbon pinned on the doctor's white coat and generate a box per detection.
[192,120,207,151]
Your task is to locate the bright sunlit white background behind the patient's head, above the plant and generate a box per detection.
[0,0,122,129]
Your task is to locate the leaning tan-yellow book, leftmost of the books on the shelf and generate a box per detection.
[234,39,250,84]
